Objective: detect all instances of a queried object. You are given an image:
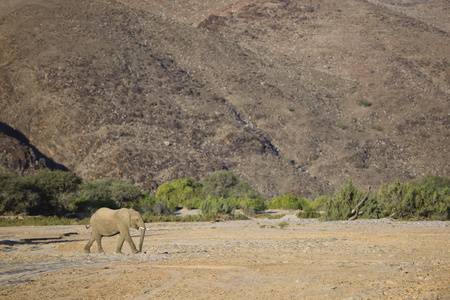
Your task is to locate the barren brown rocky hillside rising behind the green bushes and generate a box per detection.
[0,0,450,197]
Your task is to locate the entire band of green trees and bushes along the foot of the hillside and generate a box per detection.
[0,170,450,220]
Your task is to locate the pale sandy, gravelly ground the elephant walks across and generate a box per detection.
[0,215,450,299]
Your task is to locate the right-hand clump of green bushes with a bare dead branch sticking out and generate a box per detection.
[298,175,450,221]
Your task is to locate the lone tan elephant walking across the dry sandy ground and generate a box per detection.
[84,207,146,253]
